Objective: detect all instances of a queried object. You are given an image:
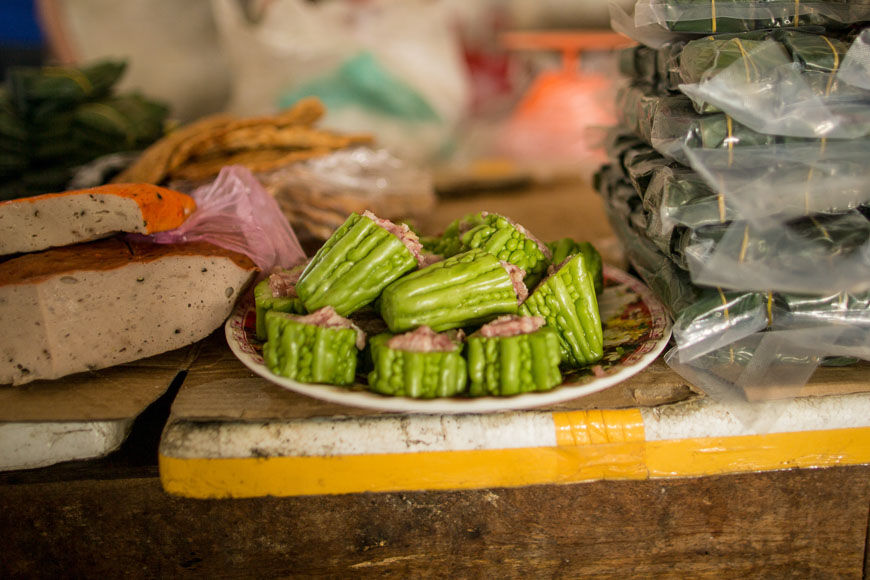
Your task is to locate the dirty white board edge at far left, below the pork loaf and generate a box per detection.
[0,419,133,471]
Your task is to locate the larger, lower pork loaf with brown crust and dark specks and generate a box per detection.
[0,237,257,384]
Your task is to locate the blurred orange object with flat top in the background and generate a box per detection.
[500,31,634,166]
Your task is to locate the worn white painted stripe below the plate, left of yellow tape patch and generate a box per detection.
[160,412,556,459]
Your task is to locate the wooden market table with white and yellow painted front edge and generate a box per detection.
[0,179,870,578]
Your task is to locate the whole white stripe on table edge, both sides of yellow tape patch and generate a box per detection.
[160,394,870,459]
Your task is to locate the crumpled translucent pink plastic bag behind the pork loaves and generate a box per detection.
[138,165,305,279]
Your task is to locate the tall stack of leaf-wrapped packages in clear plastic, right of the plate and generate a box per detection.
[596,0,870,416]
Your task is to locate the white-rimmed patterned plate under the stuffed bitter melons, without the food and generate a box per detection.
[225,266,671,414]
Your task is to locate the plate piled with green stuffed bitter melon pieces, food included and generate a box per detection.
[225,212,671,414]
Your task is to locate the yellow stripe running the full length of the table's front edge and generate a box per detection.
[160,426,870,498]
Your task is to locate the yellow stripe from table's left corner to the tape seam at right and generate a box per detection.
[159,441,647,498]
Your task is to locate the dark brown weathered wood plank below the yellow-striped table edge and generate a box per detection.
[0,466,870,578]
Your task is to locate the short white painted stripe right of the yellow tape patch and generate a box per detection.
[641,393,870,441]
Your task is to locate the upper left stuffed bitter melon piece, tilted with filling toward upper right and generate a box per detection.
[296,211,421,316]
